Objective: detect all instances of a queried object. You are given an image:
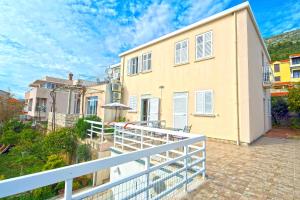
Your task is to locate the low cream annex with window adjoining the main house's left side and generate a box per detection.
[81,63,121,122]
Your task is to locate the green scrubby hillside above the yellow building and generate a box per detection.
[265,29,300,61]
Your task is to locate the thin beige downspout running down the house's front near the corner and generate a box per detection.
[233,12,240,145]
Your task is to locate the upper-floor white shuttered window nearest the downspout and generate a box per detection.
[196,31,212,60]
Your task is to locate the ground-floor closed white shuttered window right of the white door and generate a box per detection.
[196,90,213,115]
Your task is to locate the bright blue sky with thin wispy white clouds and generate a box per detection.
[0,0,300,98]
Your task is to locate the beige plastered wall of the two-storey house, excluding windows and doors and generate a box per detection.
[121,9,272,142]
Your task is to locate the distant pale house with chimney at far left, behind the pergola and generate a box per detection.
[25,74,80,121]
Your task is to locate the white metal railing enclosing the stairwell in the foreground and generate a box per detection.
[0,123,206,200]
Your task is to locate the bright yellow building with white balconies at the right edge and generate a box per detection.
[271,54,300,96]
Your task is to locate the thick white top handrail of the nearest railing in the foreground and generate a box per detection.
[0,135,205,199]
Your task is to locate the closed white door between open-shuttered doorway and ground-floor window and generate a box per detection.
[173,92,188,129]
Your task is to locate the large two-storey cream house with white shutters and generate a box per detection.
[120,2,271,143]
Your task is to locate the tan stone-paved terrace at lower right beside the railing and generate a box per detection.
[184,137,300,200]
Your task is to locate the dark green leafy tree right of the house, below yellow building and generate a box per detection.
[271,97,289,124]
